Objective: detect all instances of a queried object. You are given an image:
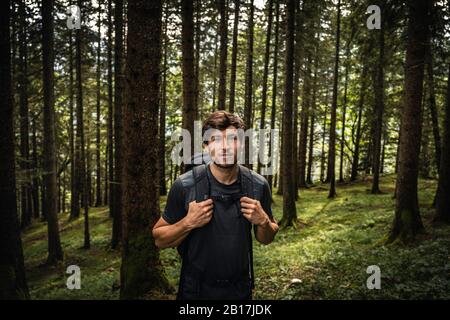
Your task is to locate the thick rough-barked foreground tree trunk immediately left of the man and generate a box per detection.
[120,0,168,299]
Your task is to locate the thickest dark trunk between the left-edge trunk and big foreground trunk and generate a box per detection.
[42,0,63,264]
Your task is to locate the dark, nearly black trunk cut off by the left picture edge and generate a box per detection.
[0,1,29,300]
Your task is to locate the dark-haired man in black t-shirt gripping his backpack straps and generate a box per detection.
[153,111,278,299]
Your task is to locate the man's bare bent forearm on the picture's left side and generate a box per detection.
[153,219,192,248]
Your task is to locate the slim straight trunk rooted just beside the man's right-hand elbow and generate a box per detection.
[280,0,297,227]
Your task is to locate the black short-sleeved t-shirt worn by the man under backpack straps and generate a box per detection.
[162,165,272,279]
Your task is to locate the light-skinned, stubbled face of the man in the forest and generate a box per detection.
[205,126,240,168]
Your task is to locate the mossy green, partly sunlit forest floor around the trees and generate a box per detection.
[22,175,450,299]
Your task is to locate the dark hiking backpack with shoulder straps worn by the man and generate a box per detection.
[177,154,258,294]
